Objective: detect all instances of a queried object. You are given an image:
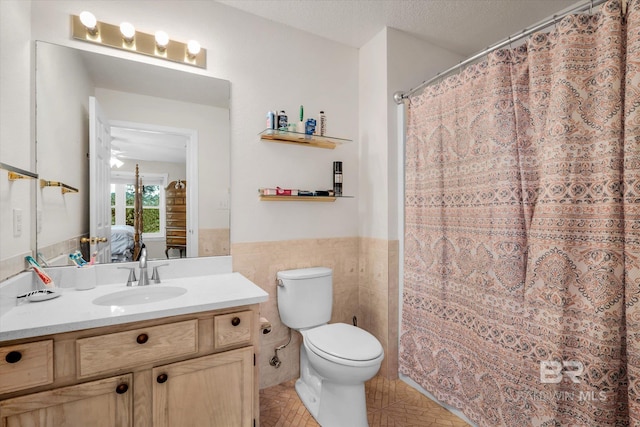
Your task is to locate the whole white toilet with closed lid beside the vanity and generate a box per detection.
[277,267,384,427]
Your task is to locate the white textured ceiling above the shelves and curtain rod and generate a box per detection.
[218,0,584,56]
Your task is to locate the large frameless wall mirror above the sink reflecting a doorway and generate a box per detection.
[35,41,230,266]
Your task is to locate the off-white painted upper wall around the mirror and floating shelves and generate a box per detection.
[0,0,359,278]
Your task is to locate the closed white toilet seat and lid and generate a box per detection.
[304,323,384,366]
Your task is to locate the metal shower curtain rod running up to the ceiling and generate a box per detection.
[393,0,608,104]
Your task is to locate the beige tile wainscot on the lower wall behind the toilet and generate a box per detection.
[231,237,398,388]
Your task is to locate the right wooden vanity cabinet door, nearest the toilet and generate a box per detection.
[153,347,254,427]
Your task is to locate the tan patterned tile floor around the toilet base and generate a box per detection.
[260,377,468,427]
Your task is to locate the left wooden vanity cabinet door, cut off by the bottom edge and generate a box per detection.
[0,374,133,427]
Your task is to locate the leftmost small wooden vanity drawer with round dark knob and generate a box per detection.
[0,340,53,393]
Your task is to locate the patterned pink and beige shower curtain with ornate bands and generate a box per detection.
[400,0,640,427]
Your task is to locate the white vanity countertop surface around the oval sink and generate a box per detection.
[0,273,268,343]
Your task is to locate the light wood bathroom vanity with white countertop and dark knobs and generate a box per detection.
[0,273,267,427]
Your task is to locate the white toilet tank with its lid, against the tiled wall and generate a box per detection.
[277,267,333,329]
